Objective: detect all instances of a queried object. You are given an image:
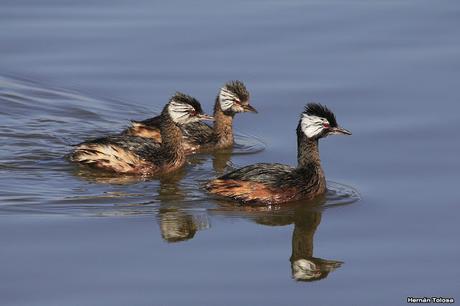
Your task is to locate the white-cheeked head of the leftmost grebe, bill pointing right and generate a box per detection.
[166,92,213,125]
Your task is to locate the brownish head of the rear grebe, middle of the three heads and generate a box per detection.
[219,81,257,113]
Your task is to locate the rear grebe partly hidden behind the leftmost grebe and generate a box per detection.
[125,81,257,153]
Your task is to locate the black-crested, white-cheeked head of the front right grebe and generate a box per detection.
[300,103,351,139]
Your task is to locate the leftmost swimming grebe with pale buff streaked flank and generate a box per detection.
[70,93,212,175]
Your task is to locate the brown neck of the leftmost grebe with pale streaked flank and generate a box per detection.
[160,112,185,163]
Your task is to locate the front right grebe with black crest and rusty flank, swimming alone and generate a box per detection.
[205,103,351,204]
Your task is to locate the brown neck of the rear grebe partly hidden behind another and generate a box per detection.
[214,97,234,148]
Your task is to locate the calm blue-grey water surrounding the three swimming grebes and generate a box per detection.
[0,0,460,305]
